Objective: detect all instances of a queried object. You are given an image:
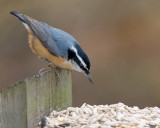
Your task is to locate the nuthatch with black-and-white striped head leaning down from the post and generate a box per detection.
[10,11,93,83]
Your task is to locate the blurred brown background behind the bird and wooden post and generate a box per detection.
[0,0,160,107]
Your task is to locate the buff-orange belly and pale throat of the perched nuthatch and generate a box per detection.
[29,34,73,70]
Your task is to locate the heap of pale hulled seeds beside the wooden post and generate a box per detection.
[41,103,160,128]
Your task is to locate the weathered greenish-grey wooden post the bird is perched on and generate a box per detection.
[0,69,72,128]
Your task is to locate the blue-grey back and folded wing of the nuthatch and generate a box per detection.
[24,16,77,58]
